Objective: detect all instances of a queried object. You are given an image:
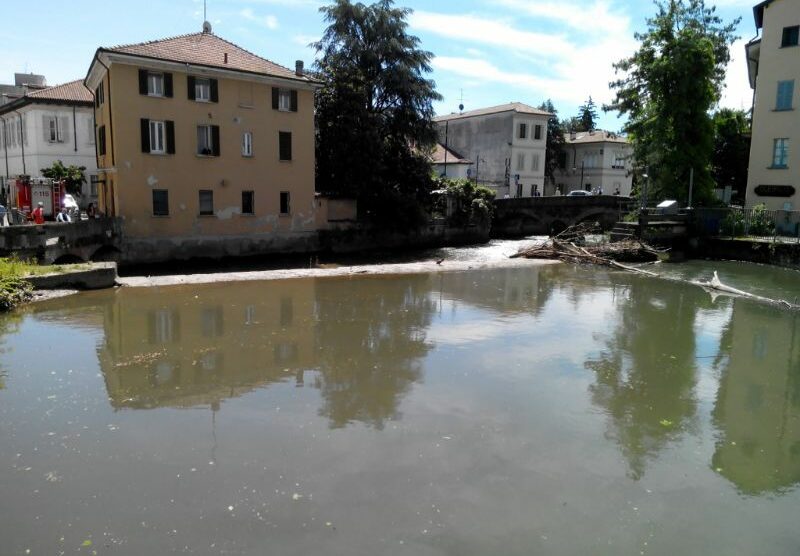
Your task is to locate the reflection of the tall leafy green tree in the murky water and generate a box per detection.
[585,276,710,479]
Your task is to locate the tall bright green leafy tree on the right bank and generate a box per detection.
[605,0,739,204]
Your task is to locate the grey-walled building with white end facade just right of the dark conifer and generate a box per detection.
[434,102,550,199]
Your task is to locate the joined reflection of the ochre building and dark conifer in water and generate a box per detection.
[99,276,435,427]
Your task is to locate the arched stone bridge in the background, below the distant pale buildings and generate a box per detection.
[492,195,634,237]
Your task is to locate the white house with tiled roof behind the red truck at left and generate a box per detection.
[0,81,97,206]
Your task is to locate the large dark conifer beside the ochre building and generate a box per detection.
[314,0,441,227]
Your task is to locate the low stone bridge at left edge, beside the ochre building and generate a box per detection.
[0,218,120,264]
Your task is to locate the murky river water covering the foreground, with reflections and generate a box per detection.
[0,242,800,555]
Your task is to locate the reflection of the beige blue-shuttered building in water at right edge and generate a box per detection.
[711,300,800,495]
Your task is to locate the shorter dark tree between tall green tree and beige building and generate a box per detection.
[711,108,750,204]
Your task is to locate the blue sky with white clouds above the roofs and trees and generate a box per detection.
[0,0,757,130]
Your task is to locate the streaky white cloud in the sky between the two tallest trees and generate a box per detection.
[410,5,637,111]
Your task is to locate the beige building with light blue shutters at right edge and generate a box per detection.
[746,0,800,210]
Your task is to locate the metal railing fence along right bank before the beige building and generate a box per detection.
[694,207,800,243]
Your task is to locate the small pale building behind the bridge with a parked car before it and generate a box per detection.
[547,129,633,197]
